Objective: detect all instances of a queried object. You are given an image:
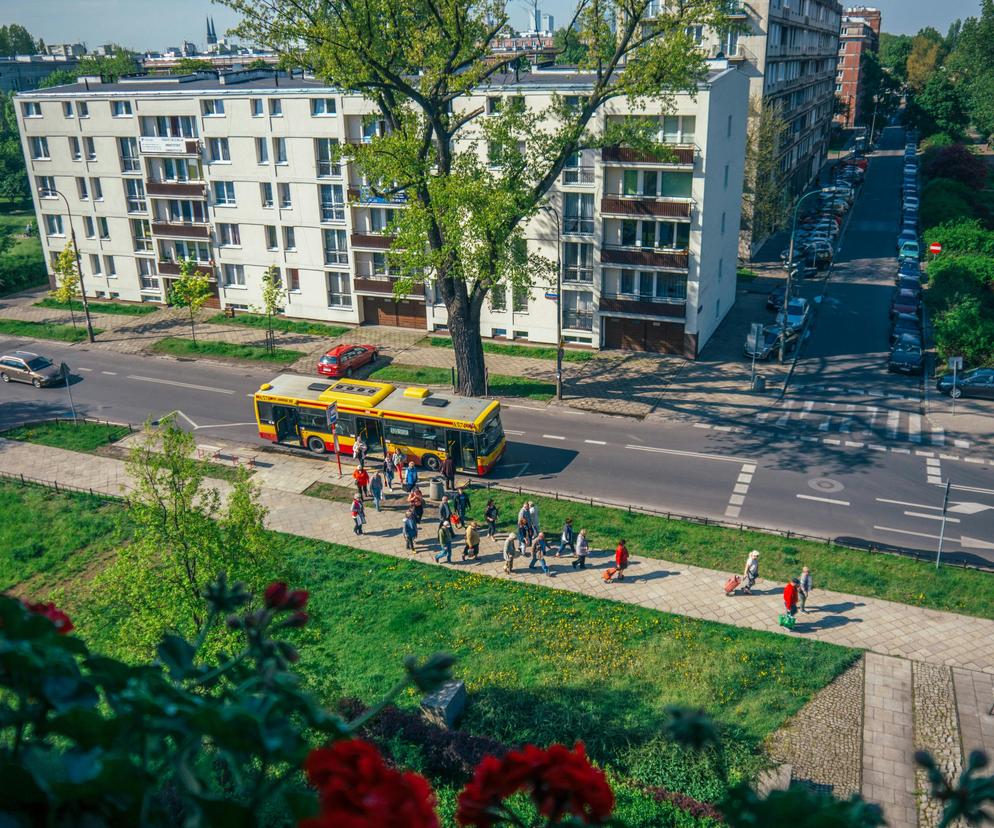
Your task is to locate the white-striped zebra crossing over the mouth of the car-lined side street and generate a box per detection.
[753,400,970,448]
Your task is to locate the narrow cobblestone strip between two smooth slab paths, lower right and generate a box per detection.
[912,662,963,828]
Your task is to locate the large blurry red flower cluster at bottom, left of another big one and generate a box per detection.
[300,739,439,828]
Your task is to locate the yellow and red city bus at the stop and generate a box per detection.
[253,374,505,475]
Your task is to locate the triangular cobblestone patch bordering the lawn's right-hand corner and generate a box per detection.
[766,658,863,799]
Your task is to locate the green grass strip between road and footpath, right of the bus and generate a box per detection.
[472,489,994,618]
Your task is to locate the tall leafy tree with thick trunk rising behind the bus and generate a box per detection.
[227,0,729,395]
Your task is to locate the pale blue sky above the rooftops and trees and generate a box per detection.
[0,0,980,51]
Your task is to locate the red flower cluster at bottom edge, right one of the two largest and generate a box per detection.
[456,742,614,828]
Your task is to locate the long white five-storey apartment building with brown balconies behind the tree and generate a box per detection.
[17,61,749,356]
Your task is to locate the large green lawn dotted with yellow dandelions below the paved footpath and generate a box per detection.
[7,481,855,828]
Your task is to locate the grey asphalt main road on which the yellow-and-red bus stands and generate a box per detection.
[0,330,994,566]
